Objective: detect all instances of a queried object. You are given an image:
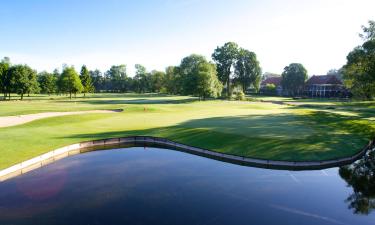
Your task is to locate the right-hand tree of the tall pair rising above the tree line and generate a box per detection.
[235,48,262,92]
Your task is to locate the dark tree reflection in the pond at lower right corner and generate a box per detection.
[339,148,375,215]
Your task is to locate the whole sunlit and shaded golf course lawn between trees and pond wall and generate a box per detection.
[0,94,375,169]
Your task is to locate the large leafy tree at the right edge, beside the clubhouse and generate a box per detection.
[343,21,375,99]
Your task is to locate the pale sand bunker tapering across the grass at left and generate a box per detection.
[0,109,122,127]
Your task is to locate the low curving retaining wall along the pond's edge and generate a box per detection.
[0,136,374,182]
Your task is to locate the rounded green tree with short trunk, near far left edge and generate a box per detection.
[9,65,37,100]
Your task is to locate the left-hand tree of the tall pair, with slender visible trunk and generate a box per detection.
[212,42,238,97]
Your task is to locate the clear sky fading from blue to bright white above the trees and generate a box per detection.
[0,0,375,76]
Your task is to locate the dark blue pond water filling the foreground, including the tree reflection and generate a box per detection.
[0,147,375,225]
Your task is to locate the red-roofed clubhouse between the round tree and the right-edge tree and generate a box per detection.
[305,75,348,98]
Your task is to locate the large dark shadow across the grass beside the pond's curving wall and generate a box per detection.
[63,112,374,161]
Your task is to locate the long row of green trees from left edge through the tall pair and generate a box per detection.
[0,42,261,100]
